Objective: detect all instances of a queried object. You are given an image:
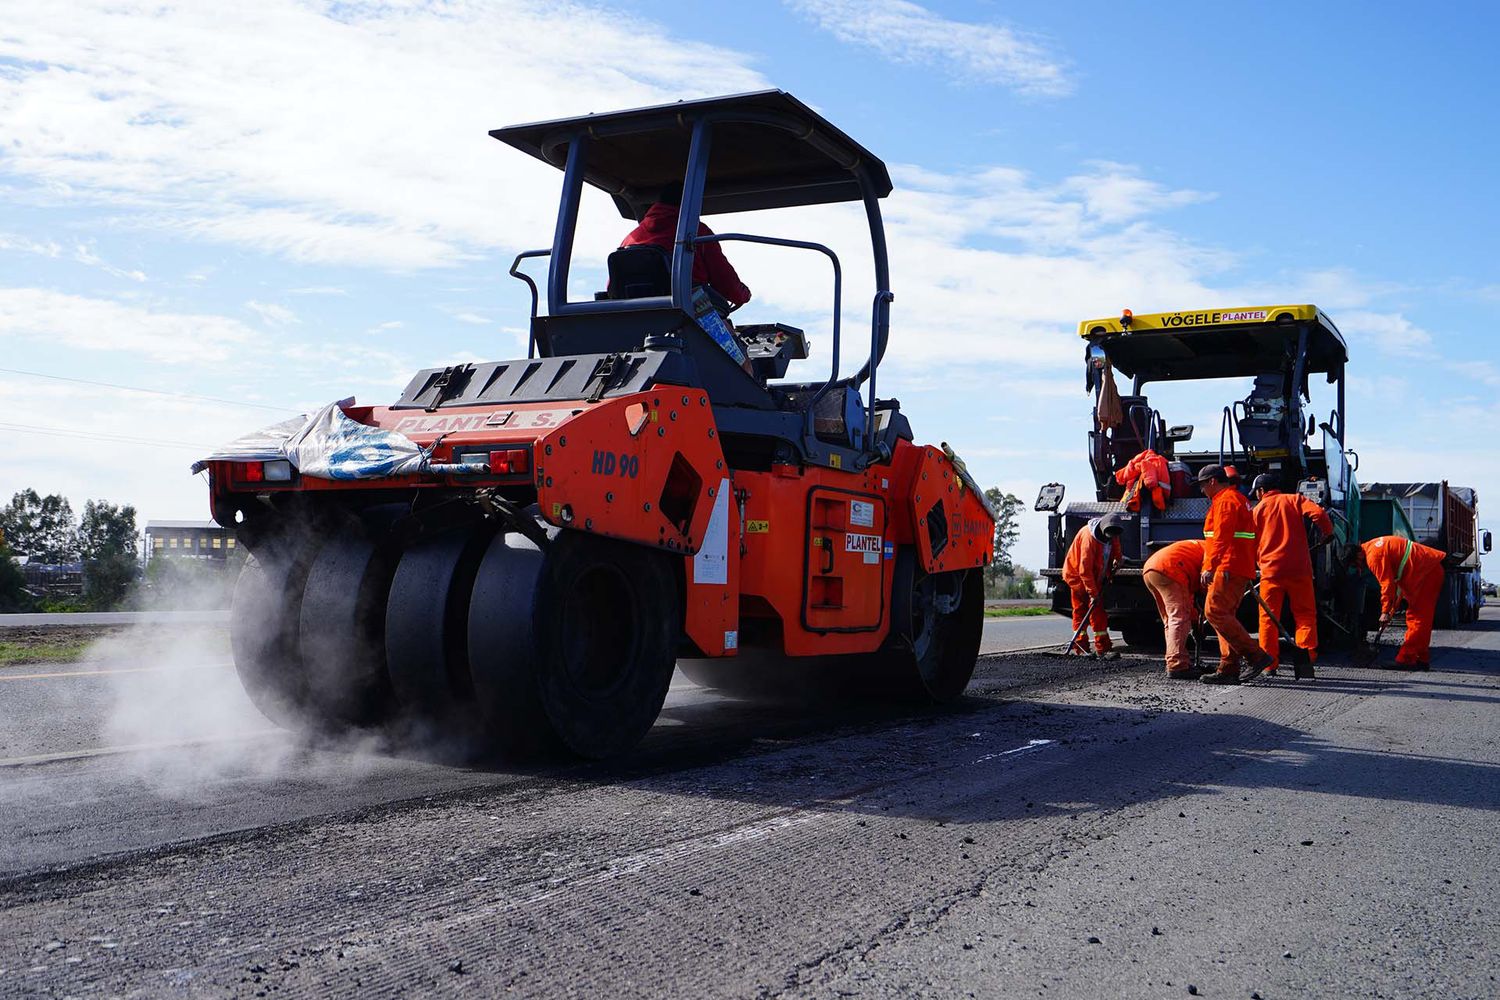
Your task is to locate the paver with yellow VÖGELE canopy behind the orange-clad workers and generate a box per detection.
[1035,304,1365,649]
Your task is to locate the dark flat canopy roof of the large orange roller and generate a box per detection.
[491,90,891,219]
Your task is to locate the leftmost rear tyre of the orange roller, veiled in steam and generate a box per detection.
[230,552,312,729]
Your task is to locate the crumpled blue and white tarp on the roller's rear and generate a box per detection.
[192,400,428,480]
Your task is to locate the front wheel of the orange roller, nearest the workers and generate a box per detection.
[888,546,984,702]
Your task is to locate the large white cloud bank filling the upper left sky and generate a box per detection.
[0,0,767,268]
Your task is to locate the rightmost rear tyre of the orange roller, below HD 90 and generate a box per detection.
[468,531,681,759]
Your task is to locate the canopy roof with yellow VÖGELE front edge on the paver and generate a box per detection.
[1079,306,1349,382]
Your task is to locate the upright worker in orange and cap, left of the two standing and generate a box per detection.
[1197,465,1272,684]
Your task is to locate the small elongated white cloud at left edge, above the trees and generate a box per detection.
[0,288,261,364]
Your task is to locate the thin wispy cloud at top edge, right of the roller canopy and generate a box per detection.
[786,0,1073,97]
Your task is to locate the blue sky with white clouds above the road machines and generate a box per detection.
[0,0,1500,565]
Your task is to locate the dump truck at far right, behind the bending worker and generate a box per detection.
[1361,480,1493,628]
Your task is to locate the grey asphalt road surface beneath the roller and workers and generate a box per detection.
[0,609,1500,1000]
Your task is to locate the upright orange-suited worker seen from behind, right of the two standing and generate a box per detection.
[1250,475,1334,673]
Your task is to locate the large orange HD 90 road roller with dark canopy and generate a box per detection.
[195,90,995,757]
